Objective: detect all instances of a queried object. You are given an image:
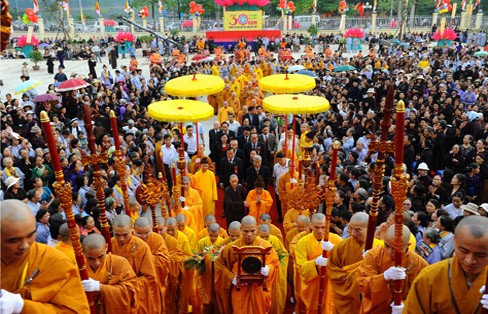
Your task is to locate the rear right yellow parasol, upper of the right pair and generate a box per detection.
[259,73,316,94]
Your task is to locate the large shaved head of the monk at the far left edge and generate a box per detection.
[0,200,36,264]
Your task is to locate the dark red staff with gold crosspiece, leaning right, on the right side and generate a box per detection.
[364,84,395,251]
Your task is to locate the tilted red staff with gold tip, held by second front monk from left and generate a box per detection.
[41,111,96,314]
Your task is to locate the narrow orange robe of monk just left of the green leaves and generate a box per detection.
[163,234,186,313]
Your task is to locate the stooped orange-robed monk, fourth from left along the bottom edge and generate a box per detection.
[134,217,171,313]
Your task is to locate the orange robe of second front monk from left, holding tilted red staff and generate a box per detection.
[86,253,139,314]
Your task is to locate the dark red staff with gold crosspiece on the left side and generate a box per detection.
[81,104,112,253]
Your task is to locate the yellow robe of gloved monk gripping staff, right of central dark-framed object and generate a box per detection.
[295,233,342,314]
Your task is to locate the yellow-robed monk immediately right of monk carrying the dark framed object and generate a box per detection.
[259,224,288,314]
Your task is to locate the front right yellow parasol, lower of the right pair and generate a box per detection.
[263,94,330,114]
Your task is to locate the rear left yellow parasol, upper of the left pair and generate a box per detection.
[164,74,225,97]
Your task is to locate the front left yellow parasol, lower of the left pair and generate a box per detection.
[148,99,214,122]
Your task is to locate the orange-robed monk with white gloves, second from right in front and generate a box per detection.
[358,225,429,313]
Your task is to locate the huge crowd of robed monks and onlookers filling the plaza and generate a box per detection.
[0,30,488,314]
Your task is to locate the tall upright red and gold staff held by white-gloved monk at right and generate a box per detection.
[391,100,409,306]
